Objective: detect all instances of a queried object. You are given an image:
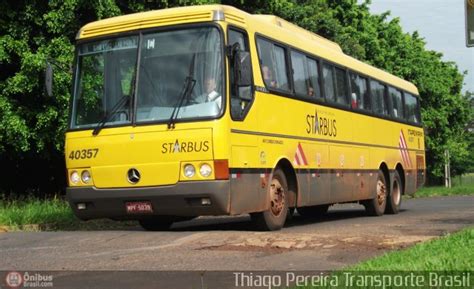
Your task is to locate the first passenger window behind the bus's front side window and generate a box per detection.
[257,39,290,91]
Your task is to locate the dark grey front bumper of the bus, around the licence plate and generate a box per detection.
[66,181,230,220]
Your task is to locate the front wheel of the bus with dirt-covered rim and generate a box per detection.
[251,168,289,231]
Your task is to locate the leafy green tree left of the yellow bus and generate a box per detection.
[0,0,129,193]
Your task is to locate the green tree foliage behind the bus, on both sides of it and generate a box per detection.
[0,0,472,193]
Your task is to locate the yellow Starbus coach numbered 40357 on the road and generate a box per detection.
[65,5,425,230]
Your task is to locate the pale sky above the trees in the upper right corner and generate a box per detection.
[366,0,474,92]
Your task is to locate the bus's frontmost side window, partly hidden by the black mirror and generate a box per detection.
[228,29,253,120]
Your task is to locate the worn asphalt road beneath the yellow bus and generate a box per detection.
[0,196,474,286]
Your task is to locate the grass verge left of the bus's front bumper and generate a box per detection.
[0,197,136,231]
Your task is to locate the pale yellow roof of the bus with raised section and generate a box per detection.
[76,5,418,95]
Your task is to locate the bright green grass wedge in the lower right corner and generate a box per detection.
[294,227,474,289]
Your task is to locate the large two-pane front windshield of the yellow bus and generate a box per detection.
[71,27,224,129]
